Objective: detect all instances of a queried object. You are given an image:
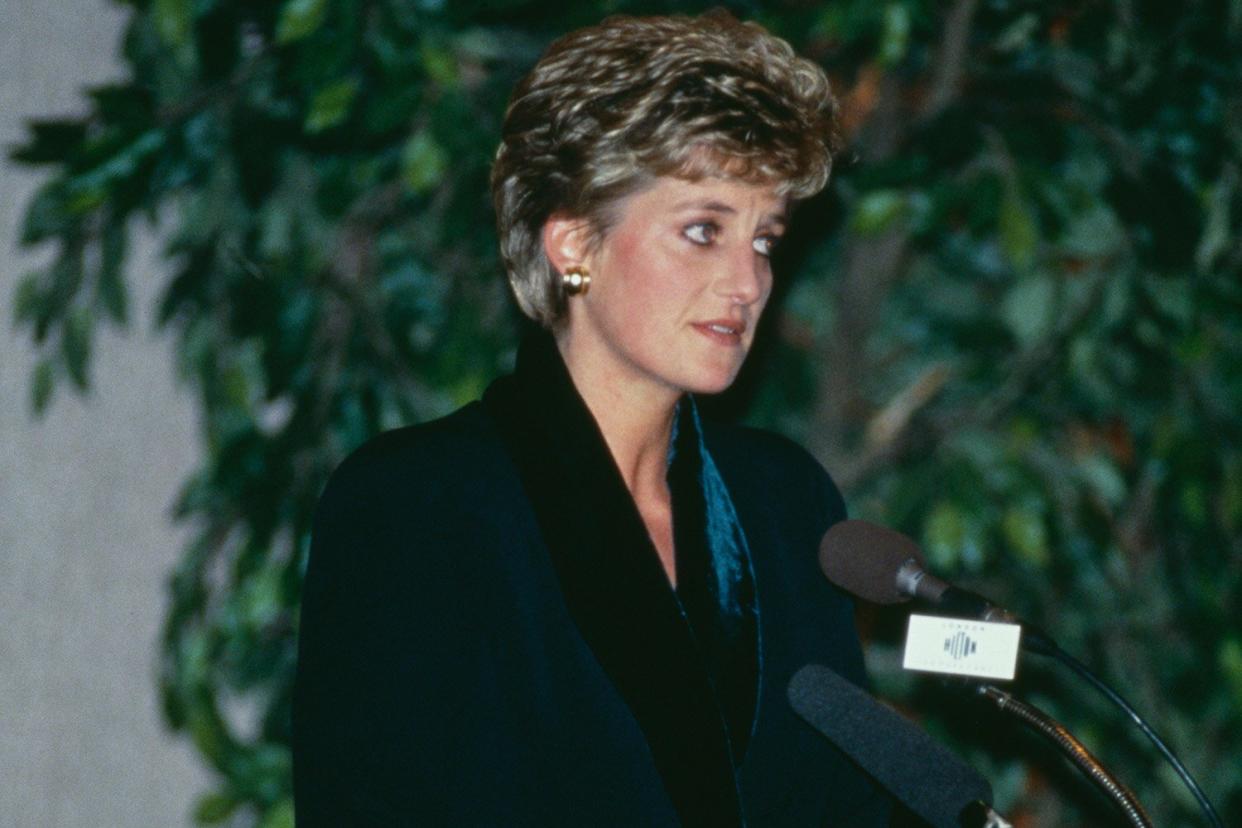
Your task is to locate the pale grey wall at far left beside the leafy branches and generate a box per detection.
[0,0,210,828]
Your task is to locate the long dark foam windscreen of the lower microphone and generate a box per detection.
[789,664,992,828]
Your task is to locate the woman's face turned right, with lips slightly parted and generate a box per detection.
[554,178,786,395]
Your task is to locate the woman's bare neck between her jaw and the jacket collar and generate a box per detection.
[556,336,681,498]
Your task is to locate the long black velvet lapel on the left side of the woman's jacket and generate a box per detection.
[483,333,743,828]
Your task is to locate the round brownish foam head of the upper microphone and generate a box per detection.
[820,520,923,603]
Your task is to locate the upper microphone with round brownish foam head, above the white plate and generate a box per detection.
[820,520,1056,653]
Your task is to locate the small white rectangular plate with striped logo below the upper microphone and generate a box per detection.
[902,613,1022,682]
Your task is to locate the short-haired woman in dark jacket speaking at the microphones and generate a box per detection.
[293,14,888,827]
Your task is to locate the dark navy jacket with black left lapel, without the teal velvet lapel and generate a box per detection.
[293,337,889,828]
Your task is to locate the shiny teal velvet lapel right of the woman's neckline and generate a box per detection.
[667,396,759,765]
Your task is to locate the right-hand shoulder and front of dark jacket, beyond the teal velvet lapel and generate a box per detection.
[704,423,887,826]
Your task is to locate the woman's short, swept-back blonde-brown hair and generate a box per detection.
[492,10,840,328]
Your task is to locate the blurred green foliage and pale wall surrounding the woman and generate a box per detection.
[0,0,1242,827]
